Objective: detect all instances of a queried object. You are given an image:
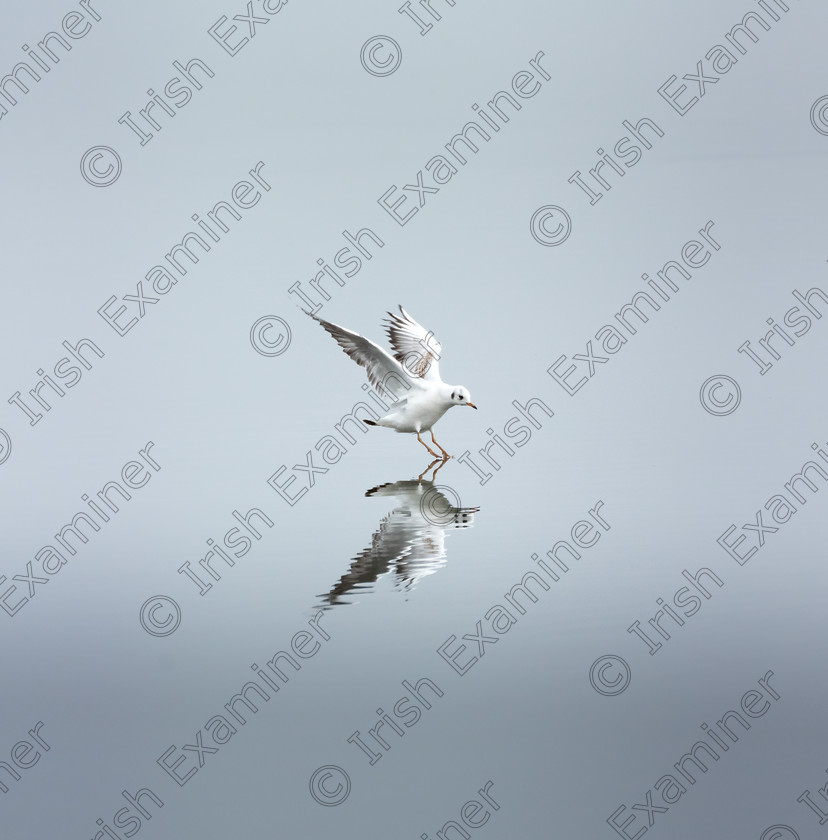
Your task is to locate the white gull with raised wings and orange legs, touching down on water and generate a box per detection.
[305,307,477,458]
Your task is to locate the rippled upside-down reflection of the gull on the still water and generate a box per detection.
[321,480,480,606]
